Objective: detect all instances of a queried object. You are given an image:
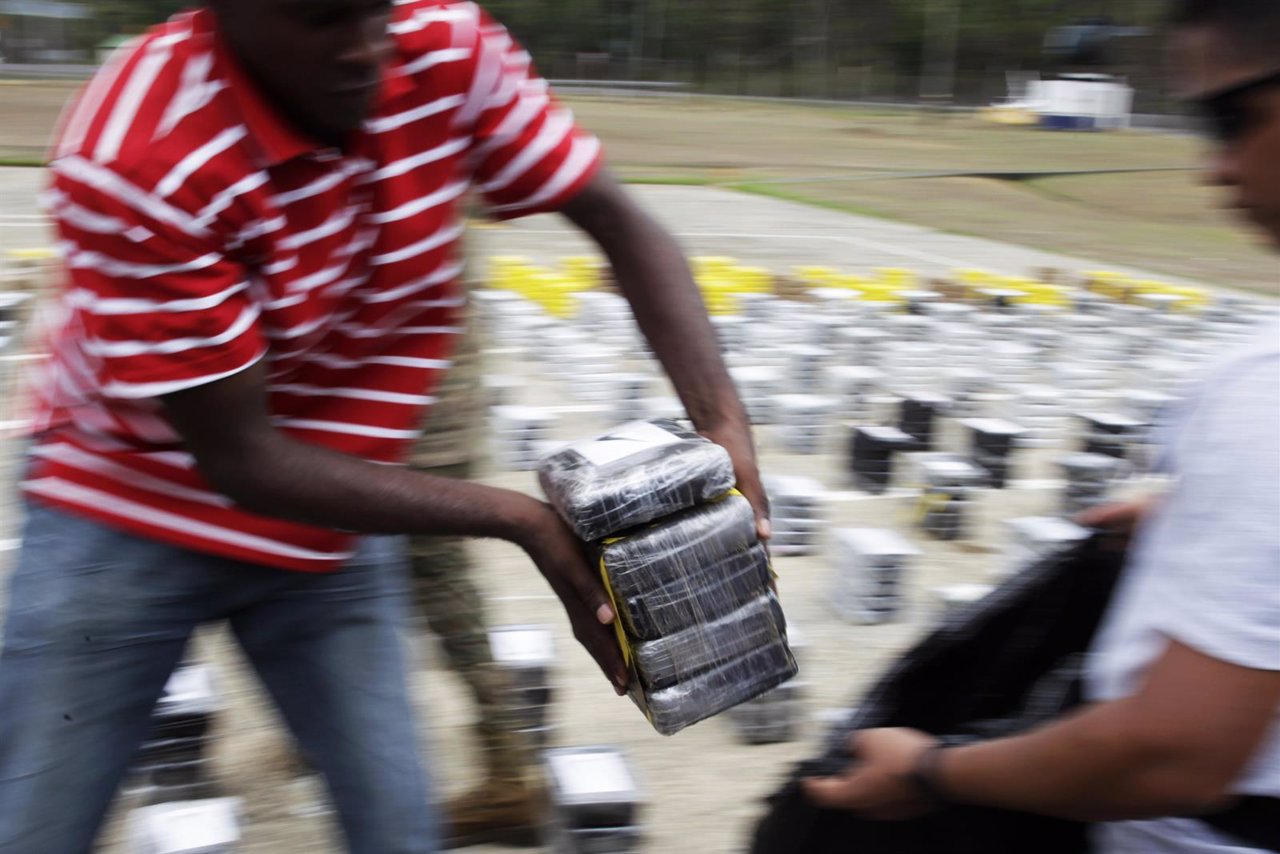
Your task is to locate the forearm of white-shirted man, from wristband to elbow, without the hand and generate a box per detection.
[938,702,1222,821]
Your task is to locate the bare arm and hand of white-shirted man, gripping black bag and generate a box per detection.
[808,641,1280,821]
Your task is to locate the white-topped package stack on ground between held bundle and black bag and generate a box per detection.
[831,528,919,625]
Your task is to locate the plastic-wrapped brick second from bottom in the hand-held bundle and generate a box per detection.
[631,593,787,690]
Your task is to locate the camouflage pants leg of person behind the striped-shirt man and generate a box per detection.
[408,465,534,785]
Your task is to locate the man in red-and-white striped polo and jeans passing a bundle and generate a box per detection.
[0,0,768,854]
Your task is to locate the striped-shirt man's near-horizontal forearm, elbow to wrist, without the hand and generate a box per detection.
[200,431,545,544]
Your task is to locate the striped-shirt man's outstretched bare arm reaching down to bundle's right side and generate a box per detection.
[563,172,769,539]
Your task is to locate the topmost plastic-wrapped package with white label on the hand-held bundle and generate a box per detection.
[539,419,735,542]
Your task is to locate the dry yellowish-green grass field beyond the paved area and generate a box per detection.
[0,81,1280,294]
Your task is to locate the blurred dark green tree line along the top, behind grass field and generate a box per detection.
[95,0,1167,106]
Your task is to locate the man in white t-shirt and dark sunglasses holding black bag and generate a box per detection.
[808,0,1280,854]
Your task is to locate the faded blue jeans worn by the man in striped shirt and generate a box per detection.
[0,504,436,854]
